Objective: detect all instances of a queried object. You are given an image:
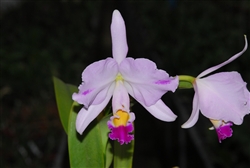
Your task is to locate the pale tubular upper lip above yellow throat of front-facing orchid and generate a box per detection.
[112,80,130,114]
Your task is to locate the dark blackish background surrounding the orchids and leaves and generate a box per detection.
[0,0,250,168]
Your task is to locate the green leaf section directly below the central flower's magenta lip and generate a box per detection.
[114,126,135,168]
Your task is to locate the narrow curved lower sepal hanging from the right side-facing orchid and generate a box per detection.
[181,92,199,128]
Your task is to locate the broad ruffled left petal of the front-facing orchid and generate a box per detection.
[72,58,118,108]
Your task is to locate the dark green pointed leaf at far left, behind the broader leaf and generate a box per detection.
[53,77,78,133]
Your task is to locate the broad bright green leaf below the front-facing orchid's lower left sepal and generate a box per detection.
[68,102,109,168]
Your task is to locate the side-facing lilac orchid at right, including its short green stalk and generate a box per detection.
[179,36,250,142]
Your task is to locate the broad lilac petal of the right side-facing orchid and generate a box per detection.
[196,72,250,125]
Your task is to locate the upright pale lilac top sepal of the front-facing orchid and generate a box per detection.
[110,10,128,64]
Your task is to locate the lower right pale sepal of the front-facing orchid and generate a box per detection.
[143,99,177,121]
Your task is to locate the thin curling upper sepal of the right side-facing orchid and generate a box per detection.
[197,36,248,78]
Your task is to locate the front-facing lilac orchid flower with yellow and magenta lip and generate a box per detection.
[72,10,179,144]
